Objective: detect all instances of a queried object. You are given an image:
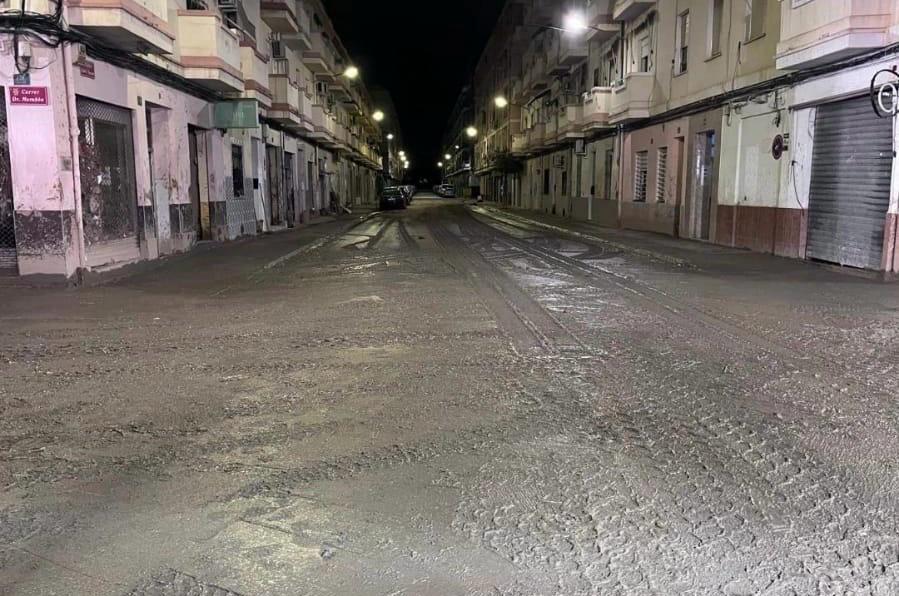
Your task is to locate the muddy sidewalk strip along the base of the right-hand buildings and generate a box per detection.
[472,202,883,281]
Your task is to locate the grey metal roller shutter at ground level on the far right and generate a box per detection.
[806,97,893,269]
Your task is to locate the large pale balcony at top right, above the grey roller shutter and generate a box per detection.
[777,0,897,70]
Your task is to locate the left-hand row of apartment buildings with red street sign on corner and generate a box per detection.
[0,0,395,277]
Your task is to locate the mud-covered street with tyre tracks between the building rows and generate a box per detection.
[0,198,899,596]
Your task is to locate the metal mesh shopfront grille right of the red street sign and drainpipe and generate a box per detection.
[77,97,140,266]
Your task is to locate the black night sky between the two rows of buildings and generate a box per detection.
[324,0,505,179]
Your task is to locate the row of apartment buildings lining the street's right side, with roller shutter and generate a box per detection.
[458,0,899,272]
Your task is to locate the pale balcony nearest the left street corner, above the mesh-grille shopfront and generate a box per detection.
[67,0,175,54]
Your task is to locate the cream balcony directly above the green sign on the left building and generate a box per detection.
[177,10,244,92]
